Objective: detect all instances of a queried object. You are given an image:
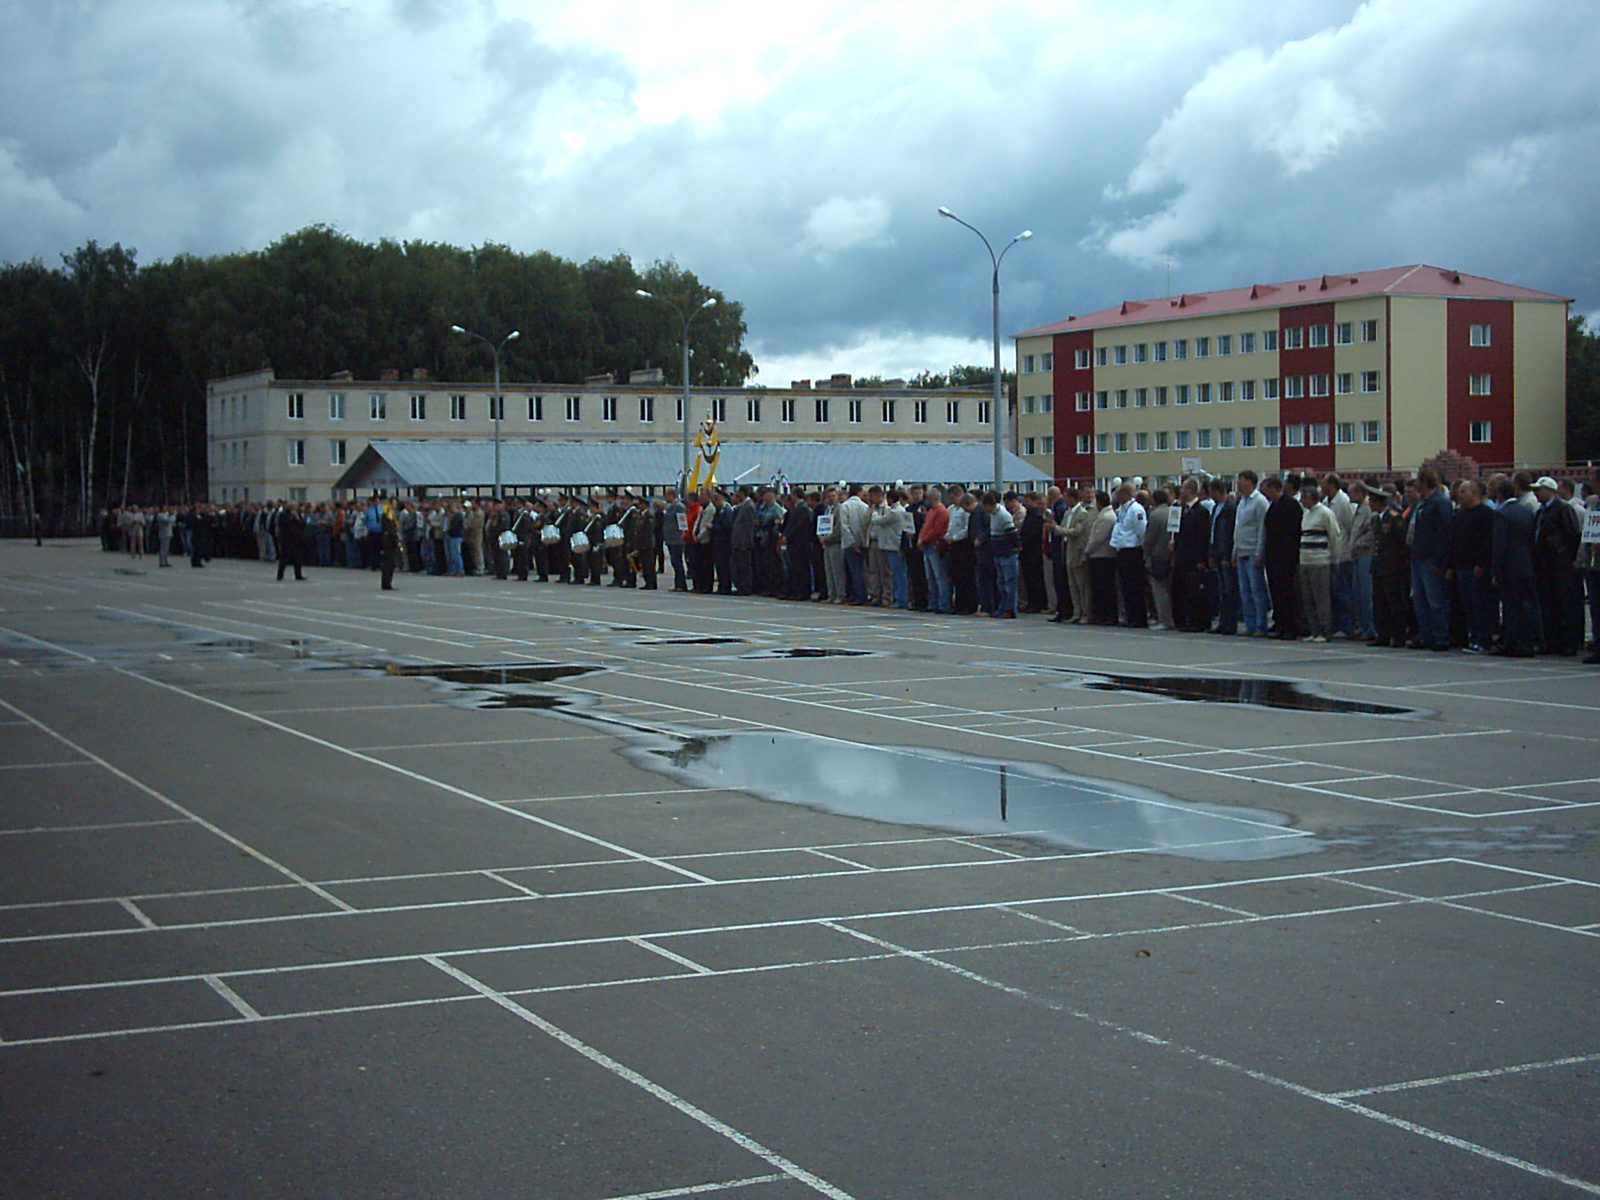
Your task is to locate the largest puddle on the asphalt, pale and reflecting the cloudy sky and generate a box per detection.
[622,733,1322,862]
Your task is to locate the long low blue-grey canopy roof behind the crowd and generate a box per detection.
[334,438,1050,491]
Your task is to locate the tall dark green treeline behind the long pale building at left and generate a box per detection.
[0,226,755,533]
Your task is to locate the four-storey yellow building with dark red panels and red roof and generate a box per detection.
[1014,266,1570,480]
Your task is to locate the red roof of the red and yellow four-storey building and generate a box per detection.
[1011,264,1571,338]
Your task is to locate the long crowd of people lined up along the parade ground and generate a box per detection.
[93,467,1600,664]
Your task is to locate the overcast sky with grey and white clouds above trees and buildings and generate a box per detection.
[0,0,1600,384]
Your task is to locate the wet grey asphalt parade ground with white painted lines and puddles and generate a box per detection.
[0,542,1600,1200]
